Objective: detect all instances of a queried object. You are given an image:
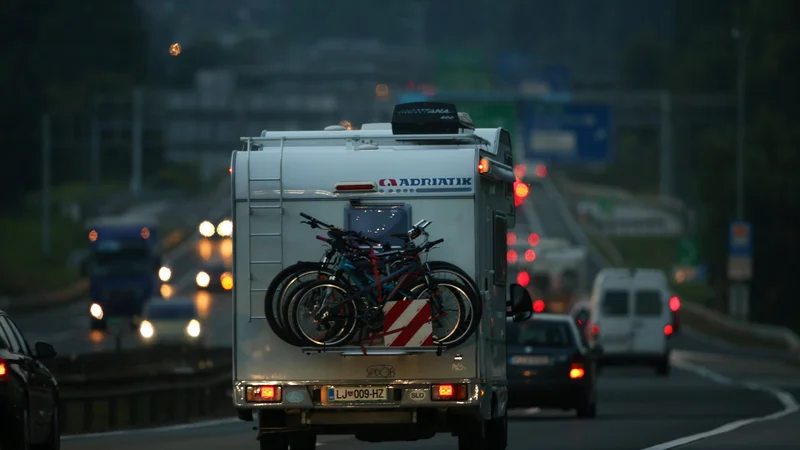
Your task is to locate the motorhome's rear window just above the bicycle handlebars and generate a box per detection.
[347,205,411,246]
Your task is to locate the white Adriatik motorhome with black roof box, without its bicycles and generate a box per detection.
[231,103,531,450]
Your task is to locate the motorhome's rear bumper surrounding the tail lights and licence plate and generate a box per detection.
[233,380,488,410]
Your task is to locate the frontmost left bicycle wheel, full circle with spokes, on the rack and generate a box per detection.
[288,280,360,347]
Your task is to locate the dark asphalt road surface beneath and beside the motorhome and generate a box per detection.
[62,348,800,450]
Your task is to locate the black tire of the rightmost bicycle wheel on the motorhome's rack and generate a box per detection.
[410,278,481,348]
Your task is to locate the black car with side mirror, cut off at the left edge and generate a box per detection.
[0,311,61,450]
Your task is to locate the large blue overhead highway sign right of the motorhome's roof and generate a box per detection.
[521,101,613,164]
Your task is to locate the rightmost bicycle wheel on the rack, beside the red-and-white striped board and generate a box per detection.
[410,278,480,348]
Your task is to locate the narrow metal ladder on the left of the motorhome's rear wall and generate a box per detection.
[247,132,286,321]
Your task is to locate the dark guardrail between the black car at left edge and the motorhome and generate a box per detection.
[52,347,234,434]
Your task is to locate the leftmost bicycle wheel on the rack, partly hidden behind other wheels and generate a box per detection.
[264,261,332,345]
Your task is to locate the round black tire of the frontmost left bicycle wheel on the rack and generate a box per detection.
[289,280,360,347]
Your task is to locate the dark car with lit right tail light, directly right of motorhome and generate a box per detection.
[506,313,600,417]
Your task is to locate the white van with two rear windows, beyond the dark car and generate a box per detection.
[587,269,674,375]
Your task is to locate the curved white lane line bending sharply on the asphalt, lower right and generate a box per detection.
[643,361,800,450]
